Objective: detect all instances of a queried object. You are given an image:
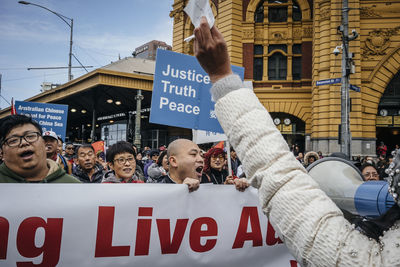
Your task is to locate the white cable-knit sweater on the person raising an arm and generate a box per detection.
[211,75,400,266]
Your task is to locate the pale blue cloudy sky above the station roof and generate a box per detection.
[0,0,173,108]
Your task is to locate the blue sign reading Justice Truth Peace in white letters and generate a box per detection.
[150,49,244,133]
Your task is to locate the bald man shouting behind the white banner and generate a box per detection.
[160,139,204,192]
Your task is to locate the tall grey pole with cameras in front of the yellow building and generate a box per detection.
[338,0,358,159]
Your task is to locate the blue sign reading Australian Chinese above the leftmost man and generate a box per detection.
[15,101,68,140]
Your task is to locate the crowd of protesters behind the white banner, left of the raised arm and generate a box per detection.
[0,115,249,194]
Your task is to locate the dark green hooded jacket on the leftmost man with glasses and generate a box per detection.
[0,159,80,183]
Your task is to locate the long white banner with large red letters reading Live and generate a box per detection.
[0,184,297,267]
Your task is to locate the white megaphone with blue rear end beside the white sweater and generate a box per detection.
[307,157,395,217]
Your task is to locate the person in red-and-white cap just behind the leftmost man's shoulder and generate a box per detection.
[43,131,72,174]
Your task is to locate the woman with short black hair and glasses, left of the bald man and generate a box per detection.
[101,141,143,183]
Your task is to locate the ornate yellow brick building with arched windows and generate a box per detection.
[170,0,400,155]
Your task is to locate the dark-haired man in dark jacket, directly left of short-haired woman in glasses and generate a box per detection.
[72,144,104,183]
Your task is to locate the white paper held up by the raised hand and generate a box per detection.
[183,0,215,29]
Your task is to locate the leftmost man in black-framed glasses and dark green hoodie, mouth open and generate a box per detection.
[0,115,79,183]
